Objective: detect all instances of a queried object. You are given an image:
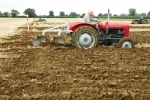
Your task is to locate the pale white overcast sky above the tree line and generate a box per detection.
[0,0,150,15]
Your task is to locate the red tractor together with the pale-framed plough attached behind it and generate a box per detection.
[33,10,134,49]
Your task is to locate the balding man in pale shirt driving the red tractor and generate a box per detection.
[83,10,101,25]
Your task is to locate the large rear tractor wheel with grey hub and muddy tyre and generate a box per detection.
[72,26,99,49]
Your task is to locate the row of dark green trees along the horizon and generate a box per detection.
[0,8,150,18]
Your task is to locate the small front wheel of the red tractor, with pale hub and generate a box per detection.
[116,38,134,48]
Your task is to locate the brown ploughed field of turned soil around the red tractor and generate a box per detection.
[0,19,150,100]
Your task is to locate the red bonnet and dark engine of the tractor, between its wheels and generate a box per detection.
[98,22,129,45]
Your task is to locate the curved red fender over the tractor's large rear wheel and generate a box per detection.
[69,23,98,32]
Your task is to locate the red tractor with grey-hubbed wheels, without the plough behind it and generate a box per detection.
[69,22,134,48]
